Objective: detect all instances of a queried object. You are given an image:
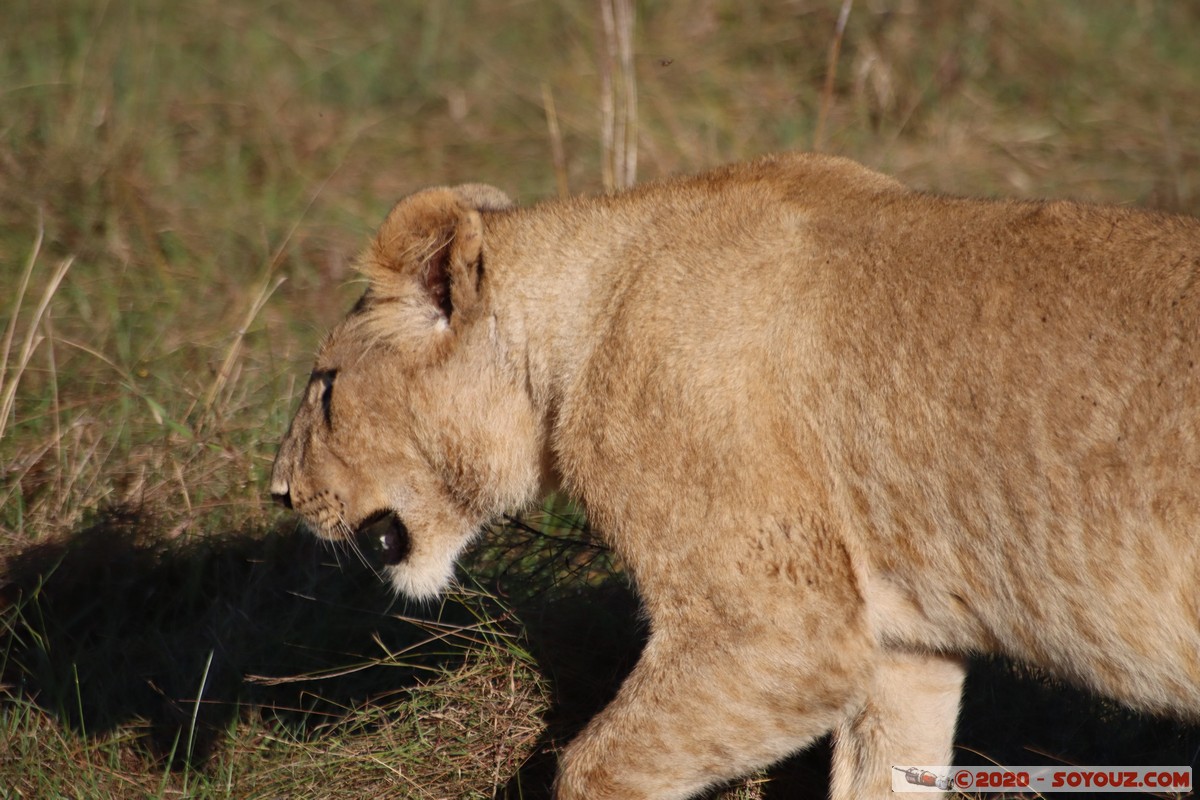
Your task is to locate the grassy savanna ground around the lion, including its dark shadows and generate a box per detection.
[0,0,1200,799]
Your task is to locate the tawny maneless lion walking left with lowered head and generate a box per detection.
[270,155,1200,800]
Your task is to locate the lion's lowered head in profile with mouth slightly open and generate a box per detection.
[271,186,542,597]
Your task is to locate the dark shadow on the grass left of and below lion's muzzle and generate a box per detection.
[0,510,487,768]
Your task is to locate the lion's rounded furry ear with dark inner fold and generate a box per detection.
[360,184,511,350]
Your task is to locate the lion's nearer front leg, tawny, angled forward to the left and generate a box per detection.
[554,609,868,800]
